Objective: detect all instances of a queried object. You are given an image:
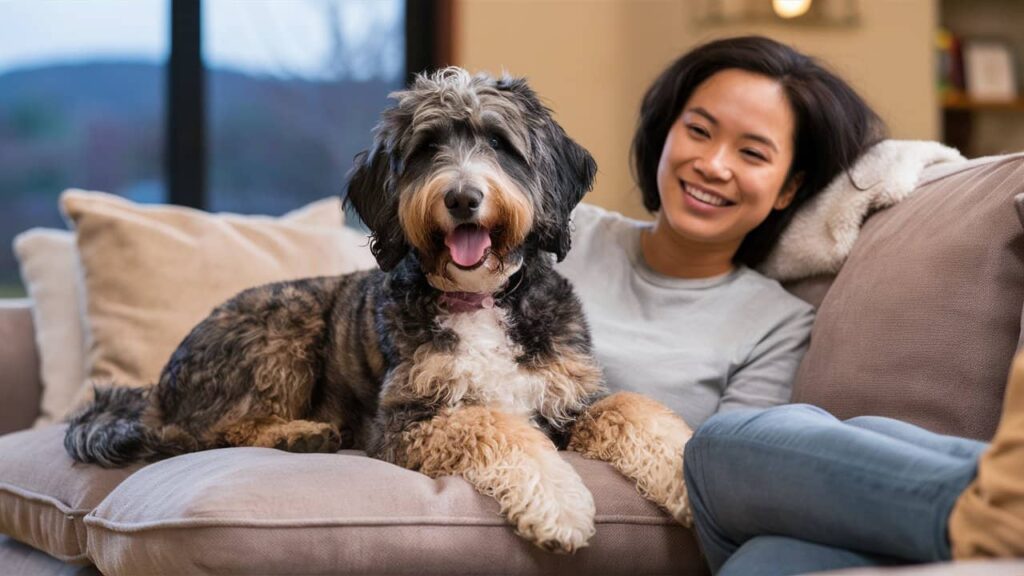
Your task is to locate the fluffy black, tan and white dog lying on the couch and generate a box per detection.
[65,68,691,552]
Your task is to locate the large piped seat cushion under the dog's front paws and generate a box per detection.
[86,448,705,575]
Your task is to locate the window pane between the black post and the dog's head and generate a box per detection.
[202,0,406,214]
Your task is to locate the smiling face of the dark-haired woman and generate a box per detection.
[657,69,799,253]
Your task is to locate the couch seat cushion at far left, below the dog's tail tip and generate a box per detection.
[0,425,139,564]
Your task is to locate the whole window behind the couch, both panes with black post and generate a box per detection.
[0,0,436,297]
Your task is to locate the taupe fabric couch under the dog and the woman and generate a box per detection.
[0,154,1024,575]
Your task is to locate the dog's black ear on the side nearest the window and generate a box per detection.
[345,142,410,272]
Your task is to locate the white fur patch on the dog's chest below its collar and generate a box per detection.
[440,307,546,414]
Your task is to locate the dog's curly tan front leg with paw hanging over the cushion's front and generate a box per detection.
[398,406,595,552]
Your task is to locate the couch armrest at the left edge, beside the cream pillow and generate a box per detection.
[0,299,43,435]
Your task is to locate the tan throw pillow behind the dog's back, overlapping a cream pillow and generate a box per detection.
[60,190,376,406]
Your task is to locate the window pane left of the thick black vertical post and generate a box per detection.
[0,0,170,296]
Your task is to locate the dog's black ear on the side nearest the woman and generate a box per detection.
[537,120,597,261]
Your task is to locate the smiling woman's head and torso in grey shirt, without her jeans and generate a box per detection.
[559,37,884,427]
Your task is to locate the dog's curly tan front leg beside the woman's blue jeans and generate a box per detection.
[569,393,693,526]
